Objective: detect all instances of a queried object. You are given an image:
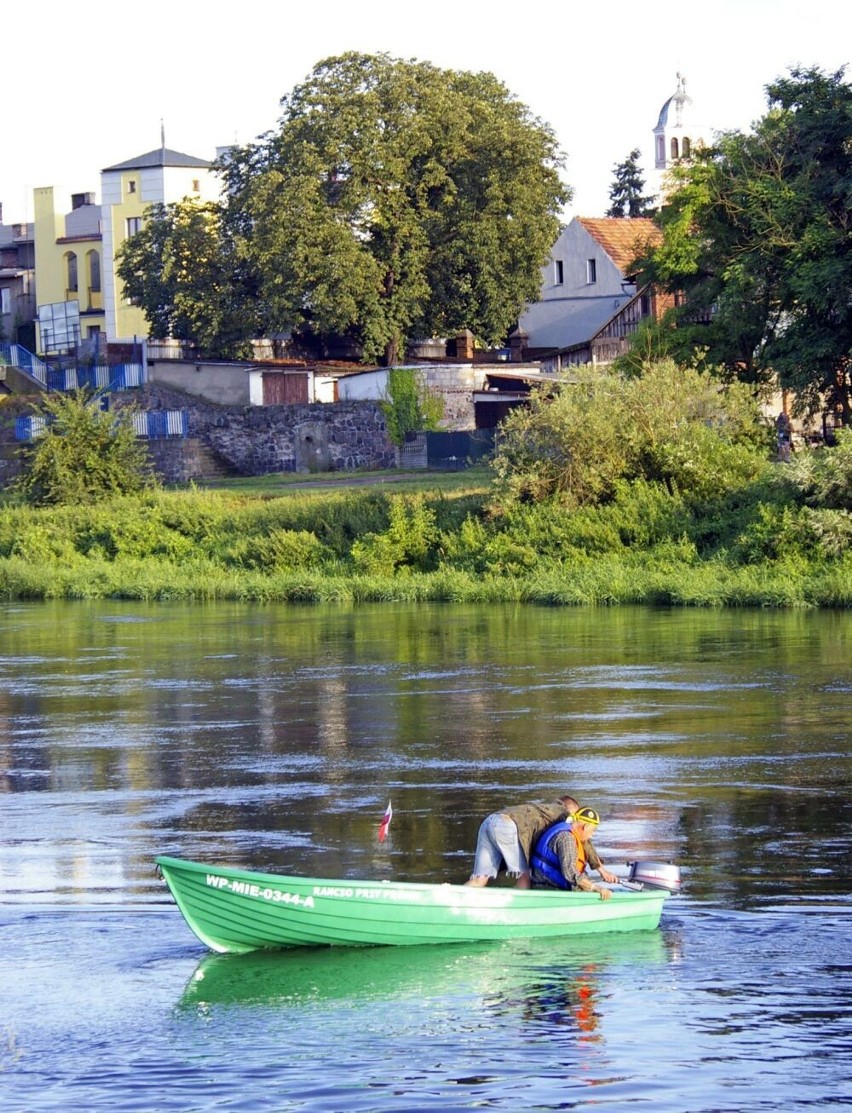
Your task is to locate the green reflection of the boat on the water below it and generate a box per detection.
[178,930,670,1027]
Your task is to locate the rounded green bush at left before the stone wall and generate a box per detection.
[17,391,154,506]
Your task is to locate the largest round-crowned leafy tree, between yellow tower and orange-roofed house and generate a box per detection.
[223,53,570,364]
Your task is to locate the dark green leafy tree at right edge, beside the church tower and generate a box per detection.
[643,69,852,424]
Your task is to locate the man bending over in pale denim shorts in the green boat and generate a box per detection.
[464,796,617,889]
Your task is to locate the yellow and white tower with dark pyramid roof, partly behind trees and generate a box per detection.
[100,146,221,341]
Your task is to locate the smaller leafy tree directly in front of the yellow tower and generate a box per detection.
[116,199,263,357]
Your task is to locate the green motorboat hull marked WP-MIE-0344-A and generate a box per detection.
[156,857,668,954]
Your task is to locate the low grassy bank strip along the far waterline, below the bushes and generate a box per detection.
[0,467,852,607]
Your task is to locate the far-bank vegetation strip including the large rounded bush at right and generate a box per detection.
[0,364,852,607]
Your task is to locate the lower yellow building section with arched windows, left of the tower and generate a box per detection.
[33,186,105,354]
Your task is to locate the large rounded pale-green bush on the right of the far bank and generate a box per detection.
[485,362,768,506]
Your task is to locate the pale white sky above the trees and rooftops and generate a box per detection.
[0,0,852,224]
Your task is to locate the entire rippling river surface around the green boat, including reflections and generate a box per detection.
[0,603,852,1113]
